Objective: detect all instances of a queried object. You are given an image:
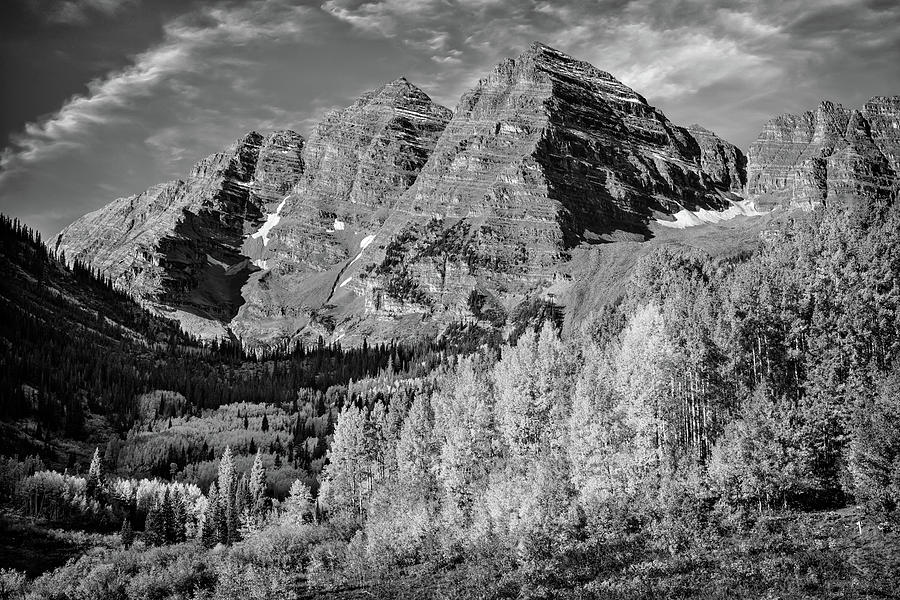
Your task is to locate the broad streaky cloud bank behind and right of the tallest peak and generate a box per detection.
[323,0,900,145]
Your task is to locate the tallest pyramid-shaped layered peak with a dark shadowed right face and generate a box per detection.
[351,44,743,328]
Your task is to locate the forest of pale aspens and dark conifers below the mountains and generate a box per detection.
[0,196,900,599]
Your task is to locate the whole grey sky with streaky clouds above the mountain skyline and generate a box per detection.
[0,0,900,239]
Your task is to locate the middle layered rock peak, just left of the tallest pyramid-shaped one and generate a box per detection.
[231,78,451,343]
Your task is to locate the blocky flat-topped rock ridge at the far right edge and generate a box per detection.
[746,96,900,208]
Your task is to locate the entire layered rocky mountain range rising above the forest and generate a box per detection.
[56,43,900,347]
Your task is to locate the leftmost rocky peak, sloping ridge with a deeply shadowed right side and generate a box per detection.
[55,131,303,335]
